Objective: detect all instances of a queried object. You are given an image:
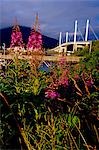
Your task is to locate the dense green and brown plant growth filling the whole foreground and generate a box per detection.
[0,51,99,150]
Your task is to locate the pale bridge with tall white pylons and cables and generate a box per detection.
[49,20,99,54]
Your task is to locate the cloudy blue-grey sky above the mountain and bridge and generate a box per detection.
[0,0,99,38]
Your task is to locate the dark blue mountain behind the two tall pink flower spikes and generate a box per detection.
[0,26,58,49]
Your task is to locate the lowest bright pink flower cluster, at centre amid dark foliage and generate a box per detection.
[45,90,59,99]
